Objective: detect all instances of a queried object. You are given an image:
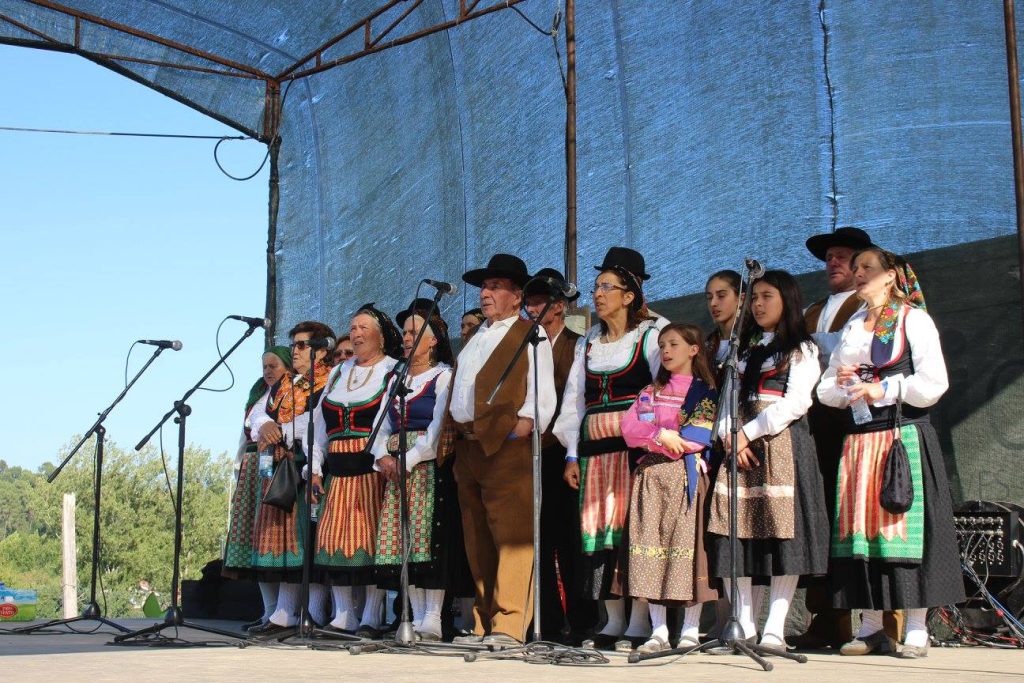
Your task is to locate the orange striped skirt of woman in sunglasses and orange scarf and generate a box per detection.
[252,445,309,584]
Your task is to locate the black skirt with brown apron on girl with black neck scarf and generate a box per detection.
[707,418,829,583]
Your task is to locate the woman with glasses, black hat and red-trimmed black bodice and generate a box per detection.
[553,247,669,649]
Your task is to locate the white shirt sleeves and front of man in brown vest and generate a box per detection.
[451,315,556,432]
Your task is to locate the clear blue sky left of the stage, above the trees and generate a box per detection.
[0,46,267,468]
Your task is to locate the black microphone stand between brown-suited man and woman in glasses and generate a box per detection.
[463,278,586,664]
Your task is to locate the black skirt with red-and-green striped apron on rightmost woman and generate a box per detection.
[829,421,965,609]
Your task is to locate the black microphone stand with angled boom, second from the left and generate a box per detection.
[111,323,257,647]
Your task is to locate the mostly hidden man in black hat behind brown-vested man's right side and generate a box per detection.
[524,268,597,641]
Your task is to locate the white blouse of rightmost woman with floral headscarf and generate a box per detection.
[818,308,949,408]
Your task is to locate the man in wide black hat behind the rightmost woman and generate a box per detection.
[790,226,902,648]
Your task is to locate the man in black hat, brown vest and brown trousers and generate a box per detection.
[450,254,556,646]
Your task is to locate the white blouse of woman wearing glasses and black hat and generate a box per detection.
[552,317,669,458]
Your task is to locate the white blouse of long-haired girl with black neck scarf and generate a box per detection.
[719,332,821,441]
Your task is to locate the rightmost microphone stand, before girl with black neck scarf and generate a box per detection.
[629,261,807,671]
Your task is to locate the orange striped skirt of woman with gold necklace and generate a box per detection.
[313,437,384,586]
